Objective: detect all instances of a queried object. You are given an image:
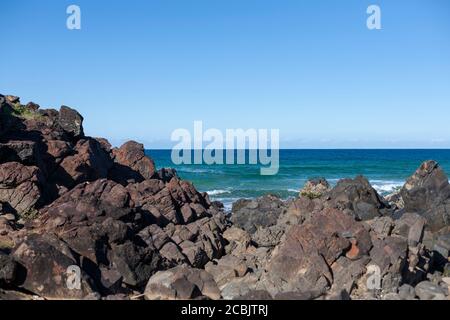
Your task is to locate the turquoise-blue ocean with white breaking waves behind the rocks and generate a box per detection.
[146,149,450,210]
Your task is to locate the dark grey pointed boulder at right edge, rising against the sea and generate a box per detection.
[400,161,450,231]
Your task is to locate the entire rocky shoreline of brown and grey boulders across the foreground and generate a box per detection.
[0,95,450,300]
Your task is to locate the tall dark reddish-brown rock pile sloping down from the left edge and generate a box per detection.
[0,96,227,299]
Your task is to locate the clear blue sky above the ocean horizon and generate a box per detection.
[0,0,450,148]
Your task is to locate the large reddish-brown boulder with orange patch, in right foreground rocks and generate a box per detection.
[267,209,372,296]
